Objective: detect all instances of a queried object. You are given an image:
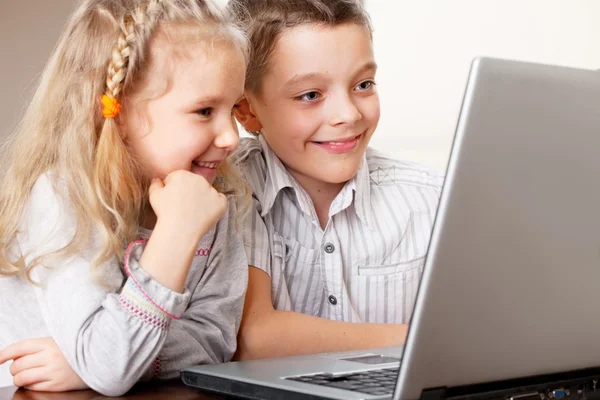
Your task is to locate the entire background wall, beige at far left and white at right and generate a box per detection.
[0,0,600,171]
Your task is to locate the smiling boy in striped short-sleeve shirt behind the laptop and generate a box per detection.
[229,0,442,359]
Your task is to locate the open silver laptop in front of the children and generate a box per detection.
[181,58,600,400]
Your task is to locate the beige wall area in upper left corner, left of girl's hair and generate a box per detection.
[0,0,75,140]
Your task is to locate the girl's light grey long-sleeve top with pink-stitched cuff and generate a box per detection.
[0,174,248,396]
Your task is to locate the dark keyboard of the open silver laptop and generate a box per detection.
[286,367,400,396]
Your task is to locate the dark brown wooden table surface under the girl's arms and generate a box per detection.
[0,380,223,400]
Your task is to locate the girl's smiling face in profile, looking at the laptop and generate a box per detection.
[125,42,246,184]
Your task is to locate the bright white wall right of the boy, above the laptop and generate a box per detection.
[366,0,600,172]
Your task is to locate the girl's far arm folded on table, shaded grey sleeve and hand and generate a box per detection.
[0,202,248,391]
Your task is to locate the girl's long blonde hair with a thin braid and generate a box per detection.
[0,0,250,282]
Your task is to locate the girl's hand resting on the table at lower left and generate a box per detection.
[0,337,88,392]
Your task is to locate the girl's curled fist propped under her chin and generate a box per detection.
[149,170,227,240]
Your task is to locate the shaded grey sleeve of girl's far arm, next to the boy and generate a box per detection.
[153,204,248,379]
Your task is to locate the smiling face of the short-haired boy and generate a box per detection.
[245,24,379,187]
